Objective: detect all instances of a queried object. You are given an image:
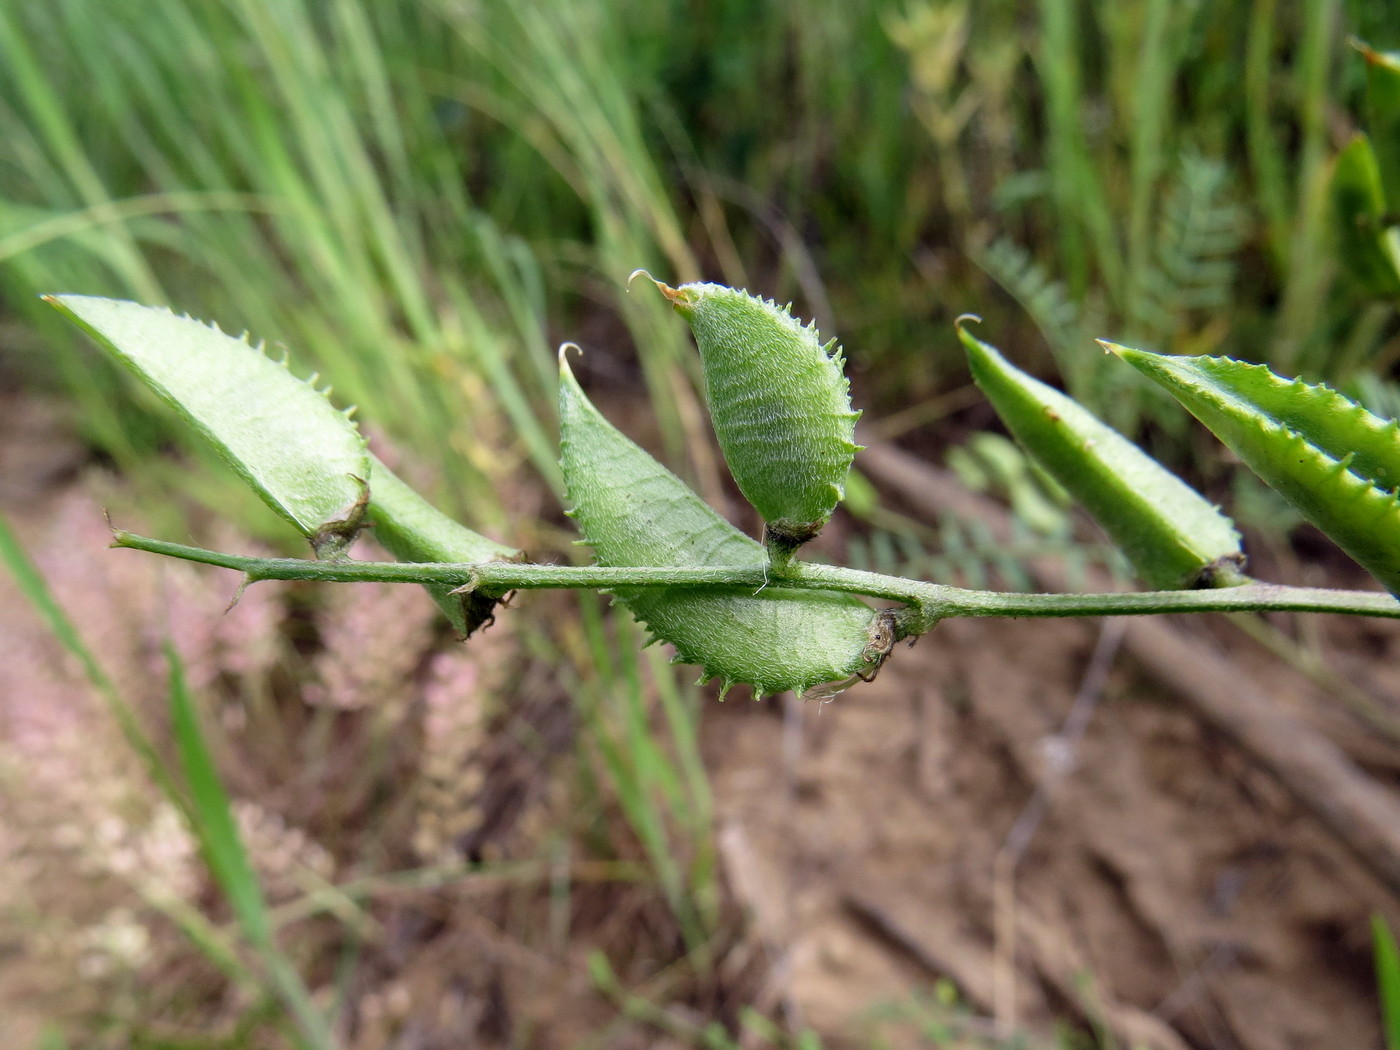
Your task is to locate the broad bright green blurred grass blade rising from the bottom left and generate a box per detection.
[165,644,335,1050]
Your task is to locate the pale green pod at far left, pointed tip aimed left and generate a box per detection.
[46,295,370,557]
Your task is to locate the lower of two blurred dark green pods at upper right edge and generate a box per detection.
[1329,134,1400,297]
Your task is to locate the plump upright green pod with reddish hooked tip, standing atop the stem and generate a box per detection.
[644,281,860,563]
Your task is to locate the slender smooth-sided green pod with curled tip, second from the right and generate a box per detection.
[958,323,1245,589]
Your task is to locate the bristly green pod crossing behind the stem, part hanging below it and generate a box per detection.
[559,358,895,696]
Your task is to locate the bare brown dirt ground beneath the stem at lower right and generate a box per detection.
[708,607,1400,1050]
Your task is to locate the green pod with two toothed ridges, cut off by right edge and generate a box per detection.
[1105,350,1400,594]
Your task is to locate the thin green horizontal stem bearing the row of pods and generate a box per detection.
[112,529,1400,636]
